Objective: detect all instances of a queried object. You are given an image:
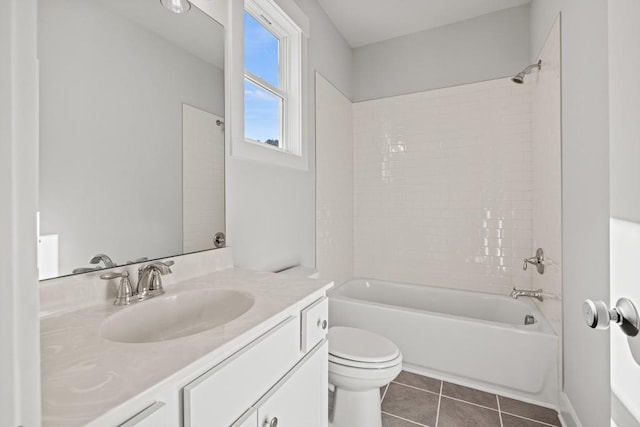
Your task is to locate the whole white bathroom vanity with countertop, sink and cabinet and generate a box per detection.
[41,250,331,427]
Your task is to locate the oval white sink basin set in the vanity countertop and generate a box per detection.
[100,289,254,343]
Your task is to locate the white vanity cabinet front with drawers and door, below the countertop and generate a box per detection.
[183,298,328,427]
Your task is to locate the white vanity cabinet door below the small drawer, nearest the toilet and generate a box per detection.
[256,340,329,427]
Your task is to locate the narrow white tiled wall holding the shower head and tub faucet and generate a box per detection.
[525,20,562,342]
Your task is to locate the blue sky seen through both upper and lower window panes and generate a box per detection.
[244,12,282,146]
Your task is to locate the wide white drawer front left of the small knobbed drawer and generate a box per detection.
[183,317,300,427]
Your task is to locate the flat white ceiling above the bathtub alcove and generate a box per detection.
[319,0,531,47]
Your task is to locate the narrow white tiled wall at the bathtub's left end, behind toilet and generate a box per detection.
[316,73,353,284]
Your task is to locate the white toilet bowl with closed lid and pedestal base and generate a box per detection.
[328,326,402,427]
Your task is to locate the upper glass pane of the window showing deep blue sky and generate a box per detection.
[244,12,280,88]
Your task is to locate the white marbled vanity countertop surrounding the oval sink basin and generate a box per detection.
[40,268,331,427]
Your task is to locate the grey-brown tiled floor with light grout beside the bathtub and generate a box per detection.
[330,371,561,427]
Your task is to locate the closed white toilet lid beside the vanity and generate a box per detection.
[329,326,400,363]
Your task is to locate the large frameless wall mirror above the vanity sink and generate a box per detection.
[38,0,225,279]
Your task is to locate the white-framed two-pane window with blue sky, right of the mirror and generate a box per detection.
[244,0,302,156]
